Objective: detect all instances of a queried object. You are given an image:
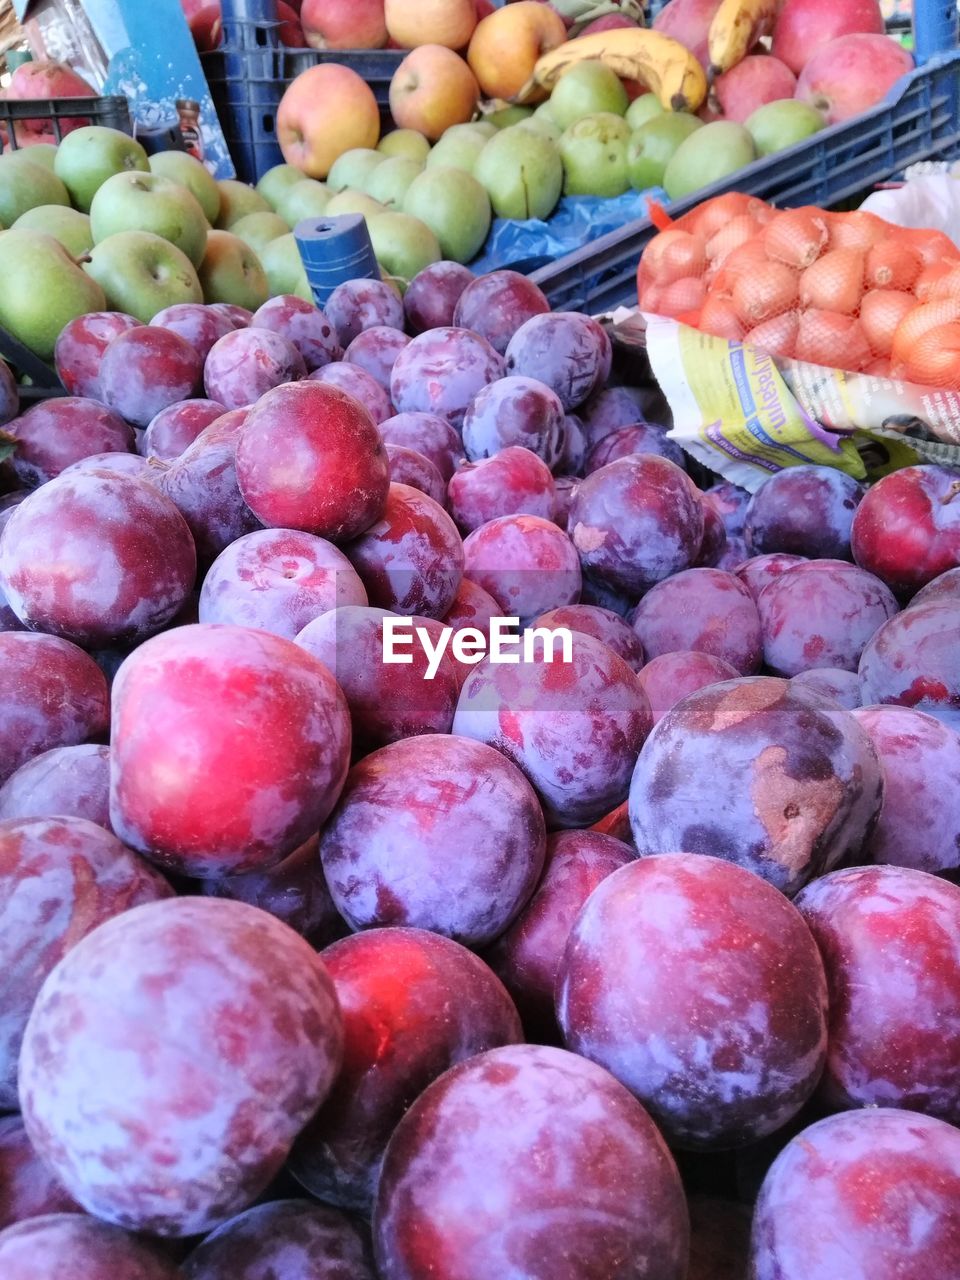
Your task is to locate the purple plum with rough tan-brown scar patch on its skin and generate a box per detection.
[630,676,883,895]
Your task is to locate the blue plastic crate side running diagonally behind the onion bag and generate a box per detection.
[531,50,960,314]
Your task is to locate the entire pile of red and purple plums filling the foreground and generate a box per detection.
[0,262,960,1280]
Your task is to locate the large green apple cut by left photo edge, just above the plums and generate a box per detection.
[0,229,106,360]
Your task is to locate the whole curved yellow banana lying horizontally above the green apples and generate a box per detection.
[516,27,707,111]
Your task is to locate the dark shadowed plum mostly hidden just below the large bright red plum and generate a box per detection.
[200,836,347,947]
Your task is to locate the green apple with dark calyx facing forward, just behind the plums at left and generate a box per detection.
[84,232,204,324]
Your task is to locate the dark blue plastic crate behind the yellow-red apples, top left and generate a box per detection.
[200,0,407,183]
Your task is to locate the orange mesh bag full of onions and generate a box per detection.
[637,195,960,389]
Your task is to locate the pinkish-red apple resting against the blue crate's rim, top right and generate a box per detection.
[794,35,914,124]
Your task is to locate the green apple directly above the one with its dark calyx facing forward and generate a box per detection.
[90,173,207,266]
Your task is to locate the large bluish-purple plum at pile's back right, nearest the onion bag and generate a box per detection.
[504,311,613,410]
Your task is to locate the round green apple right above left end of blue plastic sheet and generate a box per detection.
[474,124,563,219]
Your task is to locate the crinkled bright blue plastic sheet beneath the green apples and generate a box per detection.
[470,187,669,275]
